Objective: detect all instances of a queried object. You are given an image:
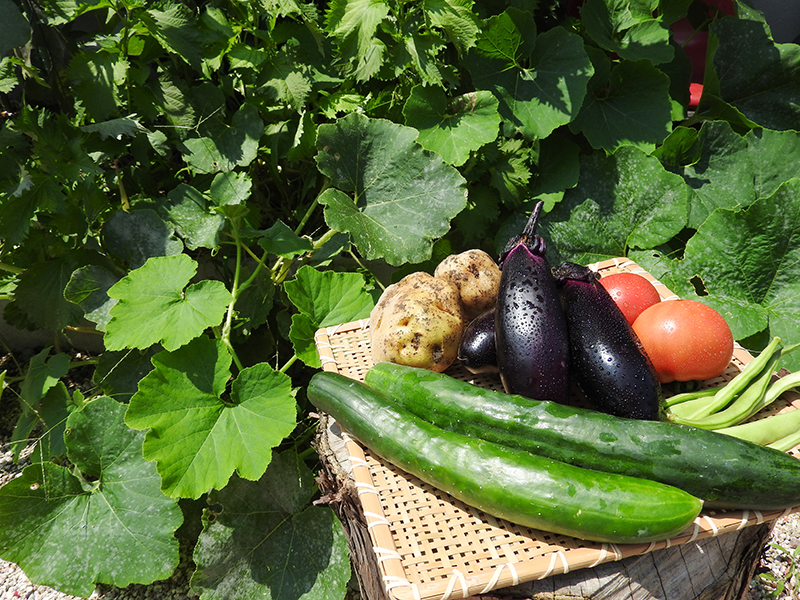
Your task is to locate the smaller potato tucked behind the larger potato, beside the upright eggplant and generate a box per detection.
[433,250,500,320]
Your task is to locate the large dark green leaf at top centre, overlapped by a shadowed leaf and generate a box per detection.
[465,15,593,138]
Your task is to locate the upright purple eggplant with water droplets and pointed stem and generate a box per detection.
[495,202,570,404]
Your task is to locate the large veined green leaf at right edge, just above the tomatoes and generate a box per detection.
[673,179,800,371]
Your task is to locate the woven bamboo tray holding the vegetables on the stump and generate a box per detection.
[315,259,800,600]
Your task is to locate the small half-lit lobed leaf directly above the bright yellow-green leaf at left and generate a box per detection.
[164,183,225,250]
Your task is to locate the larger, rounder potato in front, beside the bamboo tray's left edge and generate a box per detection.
[369,271,464,372]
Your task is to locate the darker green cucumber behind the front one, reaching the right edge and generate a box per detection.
[365,363,800,510]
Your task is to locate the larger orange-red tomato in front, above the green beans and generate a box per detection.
[633,300,733,383]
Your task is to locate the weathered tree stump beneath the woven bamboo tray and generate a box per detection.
[316,415,774,600]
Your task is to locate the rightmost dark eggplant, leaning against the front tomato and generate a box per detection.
[553,262,662,421]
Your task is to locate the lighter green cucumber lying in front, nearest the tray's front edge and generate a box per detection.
[307,371,702,543]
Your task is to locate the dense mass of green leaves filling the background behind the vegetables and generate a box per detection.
[0,0,800,600]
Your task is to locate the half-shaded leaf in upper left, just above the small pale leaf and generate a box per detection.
[183,104,264,173]
